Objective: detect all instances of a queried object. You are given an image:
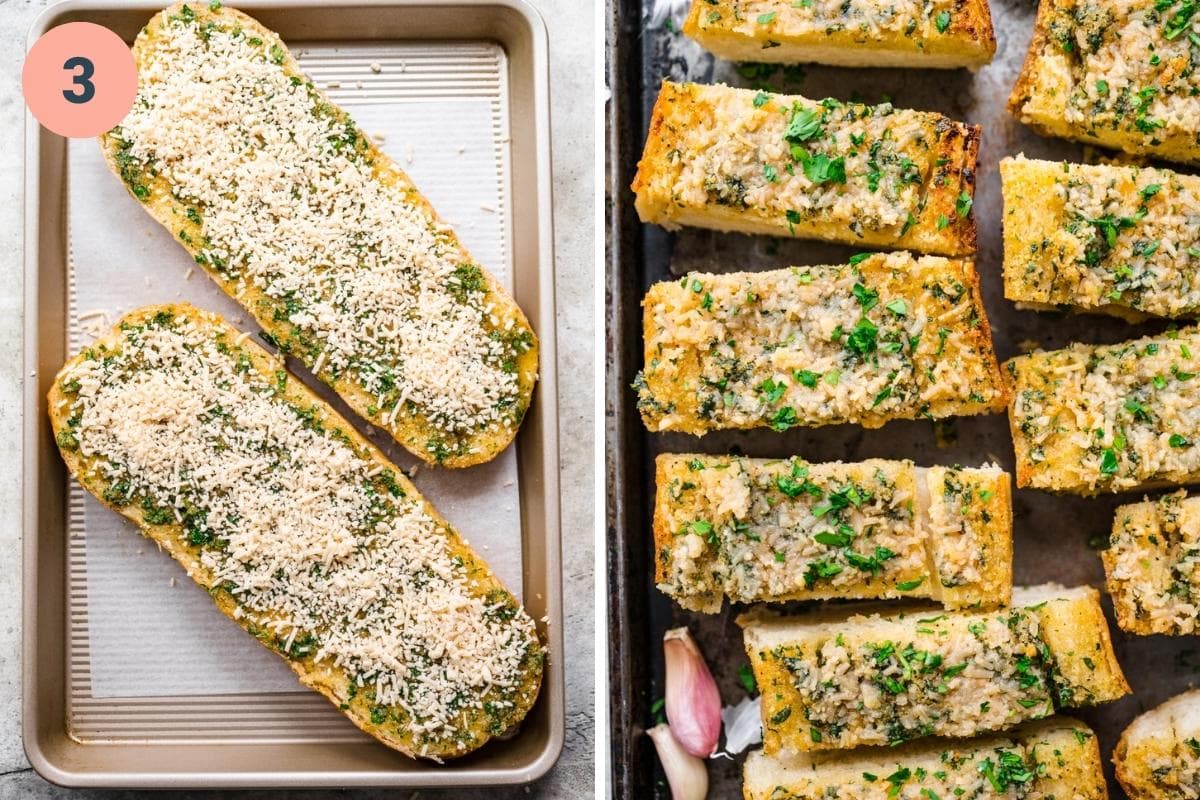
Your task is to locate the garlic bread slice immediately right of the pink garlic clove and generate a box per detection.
[738,584,1129,756]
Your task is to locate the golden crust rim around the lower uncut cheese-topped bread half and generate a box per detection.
[47,302,544,760]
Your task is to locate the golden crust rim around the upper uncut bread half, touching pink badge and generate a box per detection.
[100,2,538,468]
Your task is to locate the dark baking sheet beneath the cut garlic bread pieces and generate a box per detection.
[606,0,1200,799]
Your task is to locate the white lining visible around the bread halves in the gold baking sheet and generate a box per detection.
[67,43,522,700]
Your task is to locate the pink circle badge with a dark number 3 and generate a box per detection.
[20,23,138,138]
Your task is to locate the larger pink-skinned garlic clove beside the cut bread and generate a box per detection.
[662,627,721,758]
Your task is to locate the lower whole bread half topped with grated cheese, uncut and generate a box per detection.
[48,303,544,759]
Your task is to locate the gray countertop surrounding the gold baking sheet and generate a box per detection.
[0,0,595,800]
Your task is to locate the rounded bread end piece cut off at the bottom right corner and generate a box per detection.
[1112,688,1200,800]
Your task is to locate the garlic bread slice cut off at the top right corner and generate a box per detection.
[1008,0,1200,164]
